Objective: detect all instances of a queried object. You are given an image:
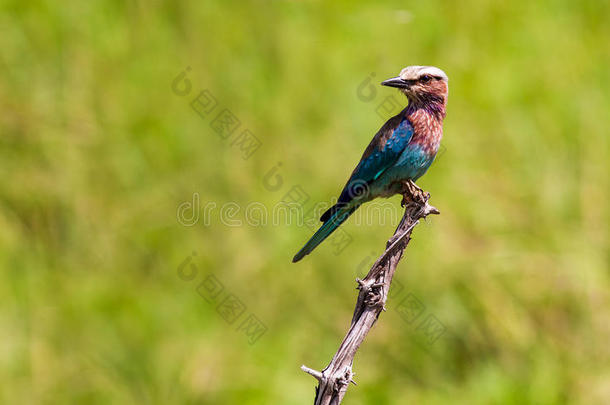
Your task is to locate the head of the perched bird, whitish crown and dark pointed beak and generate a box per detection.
[381,66,449,105]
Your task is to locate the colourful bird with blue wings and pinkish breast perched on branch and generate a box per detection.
[292,66,449,263]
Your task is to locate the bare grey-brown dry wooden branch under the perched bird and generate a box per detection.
[301,182,440,405]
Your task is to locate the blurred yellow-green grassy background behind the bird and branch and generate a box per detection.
[0,0,610,405]
